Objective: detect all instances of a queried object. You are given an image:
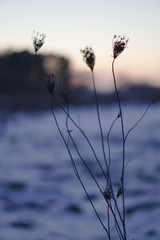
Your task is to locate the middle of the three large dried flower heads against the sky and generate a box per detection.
[80,47,95,70]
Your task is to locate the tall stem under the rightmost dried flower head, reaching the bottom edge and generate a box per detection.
[112,58,126,240]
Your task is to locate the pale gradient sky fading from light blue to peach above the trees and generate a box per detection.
[0,0,160,90]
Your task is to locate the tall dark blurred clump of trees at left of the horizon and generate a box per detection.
[0,51,78,109]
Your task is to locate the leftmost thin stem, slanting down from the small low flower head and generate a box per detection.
[51,96,111,236]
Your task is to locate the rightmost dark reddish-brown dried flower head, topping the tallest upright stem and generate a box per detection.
[113,35,129,59]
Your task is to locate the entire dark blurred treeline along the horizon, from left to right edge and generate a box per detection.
[0,51,160,111]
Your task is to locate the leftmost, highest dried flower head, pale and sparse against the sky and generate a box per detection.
[32,31,46,52]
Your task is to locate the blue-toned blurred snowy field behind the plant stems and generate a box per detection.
[0,104,160,240]
